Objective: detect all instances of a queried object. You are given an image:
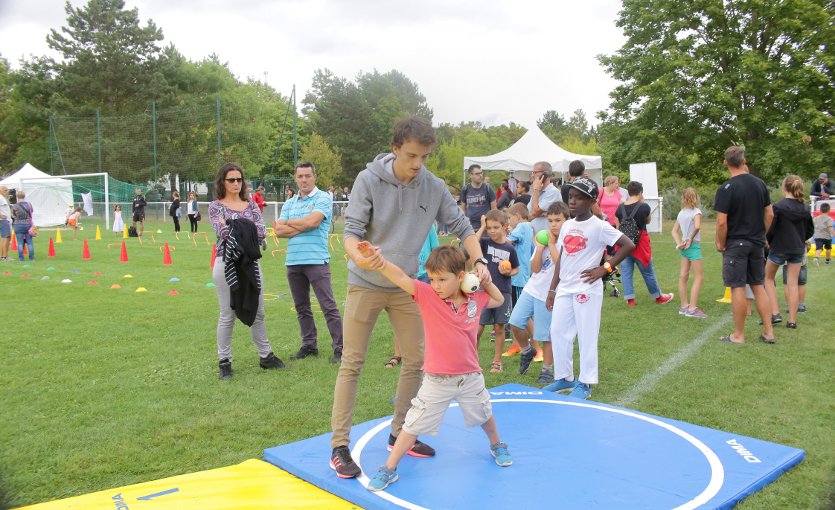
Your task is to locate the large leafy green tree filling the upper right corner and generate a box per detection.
[599,0,835,182]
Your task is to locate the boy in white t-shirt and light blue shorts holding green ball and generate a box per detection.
[510,200,571,384]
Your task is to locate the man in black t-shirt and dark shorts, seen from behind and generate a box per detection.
[713,147,776,344]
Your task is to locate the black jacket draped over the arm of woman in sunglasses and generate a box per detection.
[223,219,261,326]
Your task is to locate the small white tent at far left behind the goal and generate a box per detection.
[0,163,73,227]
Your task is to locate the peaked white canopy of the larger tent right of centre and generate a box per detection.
[464,126,603,186]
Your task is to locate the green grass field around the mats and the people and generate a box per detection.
[0,221,835,510]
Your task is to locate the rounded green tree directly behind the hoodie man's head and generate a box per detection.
[303,69,432,182]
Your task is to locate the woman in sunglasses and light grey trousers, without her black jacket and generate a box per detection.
[209,163,286,380]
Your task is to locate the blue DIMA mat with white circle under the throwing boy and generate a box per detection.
[264,384,805,510]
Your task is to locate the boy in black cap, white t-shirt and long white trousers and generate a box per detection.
[545,177,635,400]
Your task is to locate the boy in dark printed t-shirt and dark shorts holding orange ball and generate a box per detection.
[475,209,519,373]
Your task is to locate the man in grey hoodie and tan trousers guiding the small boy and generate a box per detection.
[330,117,490,478]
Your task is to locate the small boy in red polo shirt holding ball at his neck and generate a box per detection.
[357,241,513,491]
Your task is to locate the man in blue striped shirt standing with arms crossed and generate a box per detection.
[275,161,342,363]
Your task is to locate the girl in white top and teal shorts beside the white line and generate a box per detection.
[673,188,707,319]
